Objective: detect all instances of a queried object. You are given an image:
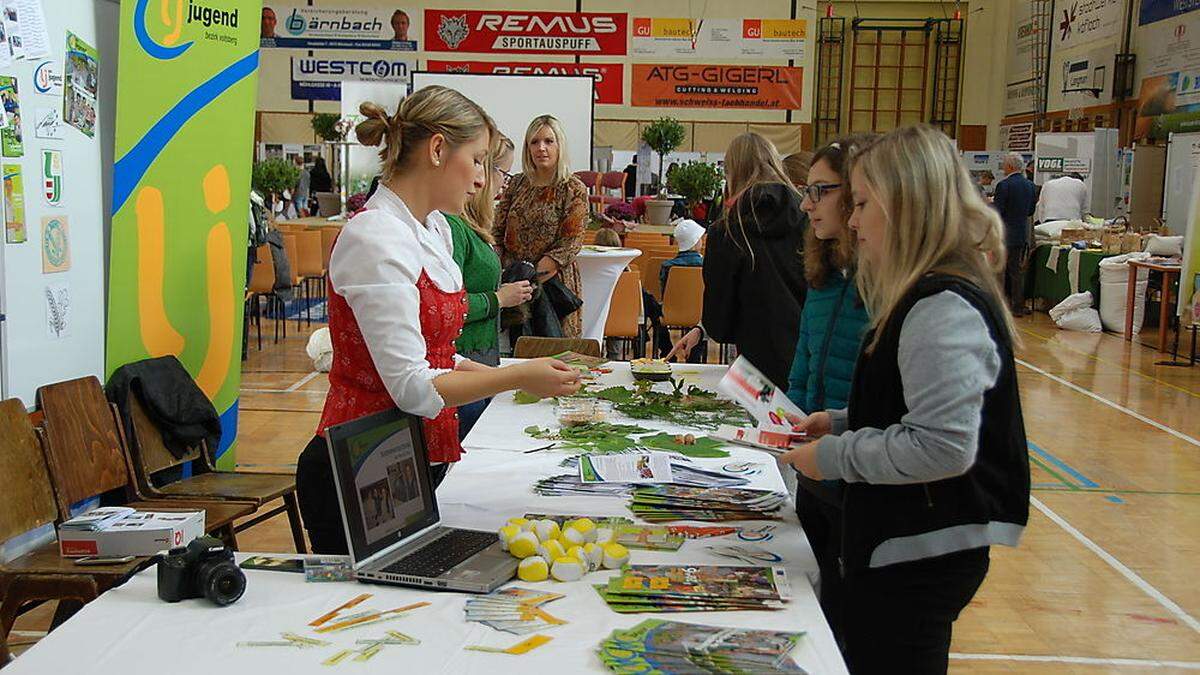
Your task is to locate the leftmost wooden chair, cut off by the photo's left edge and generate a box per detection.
[0,399,116,667]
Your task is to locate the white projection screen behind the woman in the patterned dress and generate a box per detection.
[413,72,595,173]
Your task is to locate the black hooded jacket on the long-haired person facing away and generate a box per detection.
[704,184,809,387]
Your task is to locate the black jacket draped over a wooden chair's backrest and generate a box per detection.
[104,357,221,458]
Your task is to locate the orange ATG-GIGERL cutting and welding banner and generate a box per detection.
[631,64,804,110]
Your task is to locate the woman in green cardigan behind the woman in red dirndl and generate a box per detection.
[445,136,533,438]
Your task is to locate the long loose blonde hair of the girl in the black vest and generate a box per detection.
[851,125,1019,352]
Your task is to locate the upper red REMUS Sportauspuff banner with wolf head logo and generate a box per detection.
[425,10,626,56]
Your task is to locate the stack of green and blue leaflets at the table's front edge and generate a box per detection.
[599,619,804,675]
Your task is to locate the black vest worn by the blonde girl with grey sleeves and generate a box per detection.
[840,276,1030,574]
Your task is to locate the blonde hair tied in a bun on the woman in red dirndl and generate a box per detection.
[354,85,498,180]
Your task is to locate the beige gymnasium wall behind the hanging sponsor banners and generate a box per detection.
[257,0,1004,151]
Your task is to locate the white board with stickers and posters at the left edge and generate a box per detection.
[0,0,120,407]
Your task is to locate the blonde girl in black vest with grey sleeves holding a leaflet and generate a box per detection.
[781,126,1030,675]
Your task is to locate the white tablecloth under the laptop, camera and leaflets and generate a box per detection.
[4,364,846,675]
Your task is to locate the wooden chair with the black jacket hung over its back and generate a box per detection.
[123,394,306,554]
